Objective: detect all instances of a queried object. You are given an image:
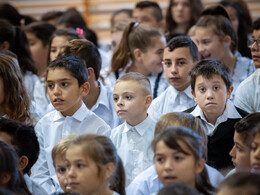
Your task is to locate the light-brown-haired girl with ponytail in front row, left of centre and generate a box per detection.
[66,134,125,195]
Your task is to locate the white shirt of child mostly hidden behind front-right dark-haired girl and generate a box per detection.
[126,164,224,195]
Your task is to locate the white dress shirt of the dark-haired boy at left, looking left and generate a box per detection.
[31,102,111,194]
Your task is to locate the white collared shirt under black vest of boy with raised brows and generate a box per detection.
[191,99,242,136]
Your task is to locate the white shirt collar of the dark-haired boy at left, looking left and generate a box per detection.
[53,102,90,121]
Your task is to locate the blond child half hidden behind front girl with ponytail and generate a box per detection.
[52,134,76,192]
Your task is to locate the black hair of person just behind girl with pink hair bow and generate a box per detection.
[57,8,98,46]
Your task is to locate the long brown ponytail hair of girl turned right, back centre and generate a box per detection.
[110,22,163,72]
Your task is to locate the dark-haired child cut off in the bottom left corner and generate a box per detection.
[0,141,32,195]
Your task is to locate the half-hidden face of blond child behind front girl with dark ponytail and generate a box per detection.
[55,156,70,192]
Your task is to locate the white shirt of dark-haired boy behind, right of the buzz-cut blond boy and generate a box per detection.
[148,86,196,121]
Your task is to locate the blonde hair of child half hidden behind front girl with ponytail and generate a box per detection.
[51,134,76,168]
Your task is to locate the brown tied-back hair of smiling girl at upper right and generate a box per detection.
[196,15,237,53]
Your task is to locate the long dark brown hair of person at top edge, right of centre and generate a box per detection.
[165,0,203,34]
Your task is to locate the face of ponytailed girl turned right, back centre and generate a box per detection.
[138,37,166,76]
